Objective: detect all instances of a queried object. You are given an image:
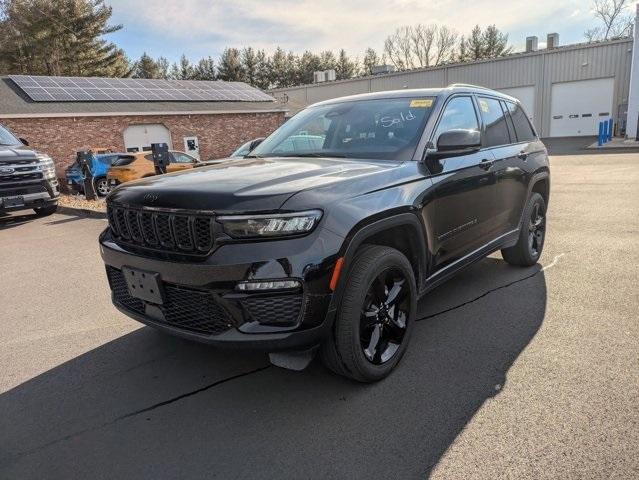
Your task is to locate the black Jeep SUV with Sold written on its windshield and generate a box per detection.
[100,85,549,381]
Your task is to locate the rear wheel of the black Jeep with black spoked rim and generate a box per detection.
[501,193,546,267]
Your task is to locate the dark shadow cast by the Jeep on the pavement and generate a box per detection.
[0,257,546,480]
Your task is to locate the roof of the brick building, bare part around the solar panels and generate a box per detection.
[0,76,287,118]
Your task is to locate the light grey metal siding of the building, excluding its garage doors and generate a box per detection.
[274,39,632,136]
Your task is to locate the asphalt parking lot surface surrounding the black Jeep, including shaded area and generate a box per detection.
[0,141,639,480]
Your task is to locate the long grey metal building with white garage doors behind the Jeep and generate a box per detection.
[271,34,639,137]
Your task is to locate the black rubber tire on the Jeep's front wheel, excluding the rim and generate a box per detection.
[337,250,417,381]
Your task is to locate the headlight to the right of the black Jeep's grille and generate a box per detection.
[217,210,322,238]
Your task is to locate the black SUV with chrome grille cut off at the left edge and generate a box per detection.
[0,125,60,215]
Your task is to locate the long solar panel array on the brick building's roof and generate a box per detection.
[9,75,273,102]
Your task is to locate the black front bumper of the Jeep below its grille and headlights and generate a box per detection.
[100,229,341,351]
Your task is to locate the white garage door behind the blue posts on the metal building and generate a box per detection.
[550,78,615,137]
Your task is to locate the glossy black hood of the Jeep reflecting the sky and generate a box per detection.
[108,157,398,213]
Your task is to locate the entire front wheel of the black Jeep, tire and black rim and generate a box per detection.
[320,245,417,382]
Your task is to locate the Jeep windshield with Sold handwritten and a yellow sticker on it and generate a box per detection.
[250,97,434,161]
